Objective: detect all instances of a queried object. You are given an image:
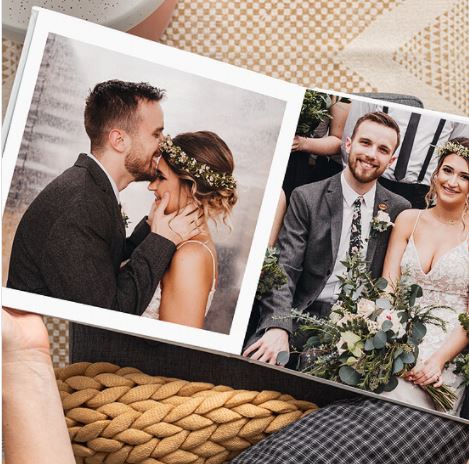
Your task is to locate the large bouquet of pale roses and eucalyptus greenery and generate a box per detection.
[293,254,455,409]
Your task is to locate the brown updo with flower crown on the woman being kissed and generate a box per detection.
[161,131,238,225]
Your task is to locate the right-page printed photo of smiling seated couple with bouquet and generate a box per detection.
[243,90,469,419]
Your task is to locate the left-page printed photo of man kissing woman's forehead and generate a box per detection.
[3,16,302,356]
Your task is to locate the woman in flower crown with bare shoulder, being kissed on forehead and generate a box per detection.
[143,131,237,328]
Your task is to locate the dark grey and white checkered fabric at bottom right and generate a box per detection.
[231,398,469,464]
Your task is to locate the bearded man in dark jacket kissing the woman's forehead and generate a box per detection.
[7,80,198,362]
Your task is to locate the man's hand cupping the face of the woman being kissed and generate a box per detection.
[148,192,203,246]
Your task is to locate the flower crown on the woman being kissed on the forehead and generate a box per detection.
[160,135,236,190]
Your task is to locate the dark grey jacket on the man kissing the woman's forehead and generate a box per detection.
[7,154,176,359]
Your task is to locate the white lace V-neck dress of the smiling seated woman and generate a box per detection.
[383,214,469,414]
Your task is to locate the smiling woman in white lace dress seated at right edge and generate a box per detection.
[383,138,469,414]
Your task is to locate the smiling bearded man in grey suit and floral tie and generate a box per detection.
[243,112,410,364]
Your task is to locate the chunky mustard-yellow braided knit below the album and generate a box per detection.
[56,362,318,464]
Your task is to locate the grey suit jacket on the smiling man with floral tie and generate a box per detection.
[255,174,410,338]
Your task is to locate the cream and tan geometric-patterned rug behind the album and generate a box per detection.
[2,0,469,367]
